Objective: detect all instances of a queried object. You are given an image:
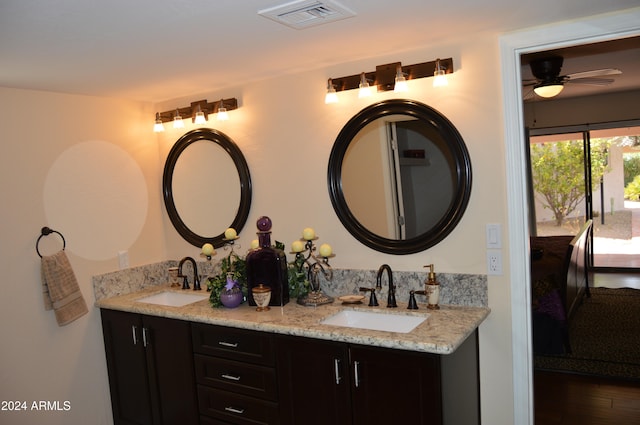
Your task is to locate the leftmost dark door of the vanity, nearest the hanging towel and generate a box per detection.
[101,310,157,425]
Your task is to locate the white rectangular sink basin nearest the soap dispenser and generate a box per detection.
[320,310,428,333]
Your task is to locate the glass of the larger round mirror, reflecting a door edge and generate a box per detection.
[342,115,456,240]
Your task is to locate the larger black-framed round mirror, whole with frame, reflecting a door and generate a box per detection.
[327,99,471,254]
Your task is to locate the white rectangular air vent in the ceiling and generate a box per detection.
[258,0,356,29]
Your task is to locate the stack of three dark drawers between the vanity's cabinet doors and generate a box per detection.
[192,323,280,425]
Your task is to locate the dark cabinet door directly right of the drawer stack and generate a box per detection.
[277,337,352,425]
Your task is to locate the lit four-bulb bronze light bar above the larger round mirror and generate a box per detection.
[325,58,453,103]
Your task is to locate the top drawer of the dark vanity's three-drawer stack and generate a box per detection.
[191,323,275,366]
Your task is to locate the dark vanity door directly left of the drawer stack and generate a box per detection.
[142,316,199,425]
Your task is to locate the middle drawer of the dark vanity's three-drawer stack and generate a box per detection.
[195,354,277,401]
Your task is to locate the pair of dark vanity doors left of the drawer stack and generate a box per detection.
[101,309,198,425]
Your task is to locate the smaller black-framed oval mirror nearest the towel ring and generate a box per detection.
[162,128,251,248]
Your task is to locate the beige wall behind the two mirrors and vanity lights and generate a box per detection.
[156,34,513,425]
